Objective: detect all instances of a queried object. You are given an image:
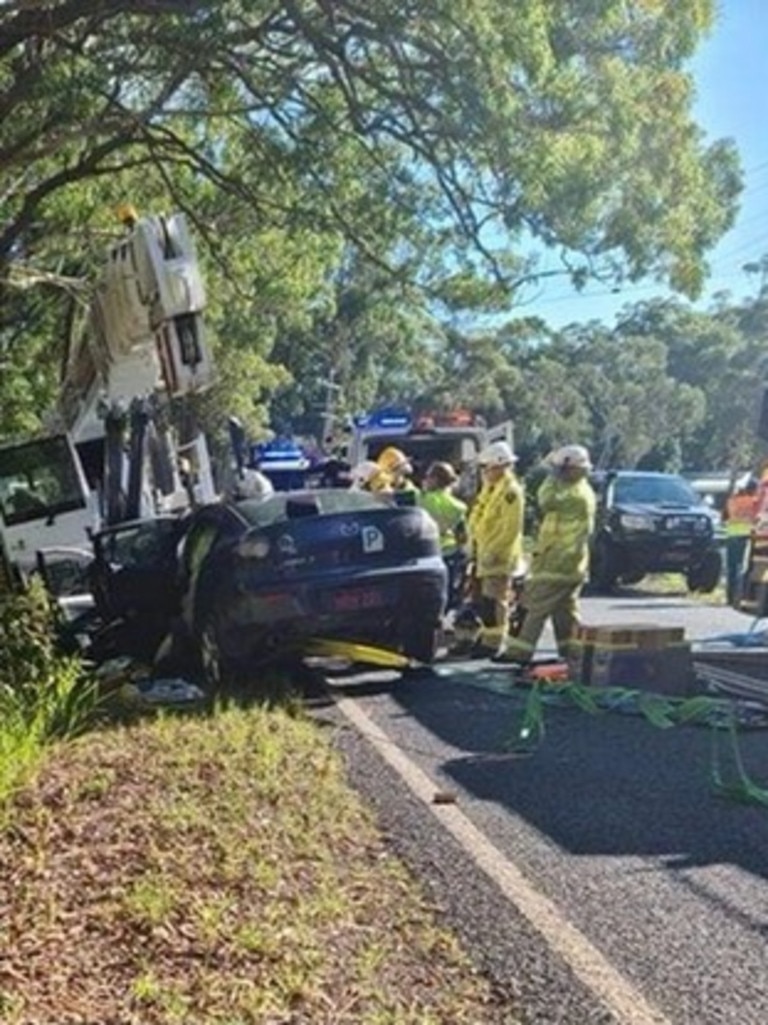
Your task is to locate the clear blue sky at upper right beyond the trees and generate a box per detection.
[521,0,768,327]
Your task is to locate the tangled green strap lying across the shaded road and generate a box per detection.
[509,682,768,807]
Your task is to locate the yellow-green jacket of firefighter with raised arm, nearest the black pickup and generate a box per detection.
[531,477,596,583]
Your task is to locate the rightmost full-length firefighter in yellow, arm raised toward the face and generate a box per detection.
[493,445,596,666]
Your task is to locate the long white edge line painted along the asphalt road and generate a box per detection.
[336,698,672,1025]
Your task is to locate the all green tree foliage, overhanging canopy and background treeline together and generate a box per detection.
[0,0,757,463]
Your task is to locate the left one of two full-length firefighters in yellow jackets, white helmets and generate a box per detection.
[459,442,524,654]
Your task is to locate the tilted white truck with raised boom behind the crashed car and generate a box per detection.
[0,209,214,576]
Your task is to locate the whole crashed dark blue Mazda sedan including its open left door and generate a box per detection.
[86,489,447,686]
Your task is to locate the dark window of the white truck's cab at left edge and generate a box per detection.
[0,437,86,527]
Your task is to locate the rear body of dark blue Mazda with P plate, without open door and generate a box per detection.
[174,489,447,684]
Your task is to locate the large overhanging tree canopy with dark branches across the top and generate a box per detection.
[0,0,739,436]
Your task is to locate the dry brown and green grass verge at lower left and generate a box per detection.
[0,707,515,1025]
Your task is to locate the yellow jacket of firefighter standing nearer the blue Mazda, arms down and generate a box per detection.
[468,469,525,577]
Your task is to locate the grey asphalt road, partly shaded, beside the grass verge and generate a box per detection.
[307,591,768,1025]
